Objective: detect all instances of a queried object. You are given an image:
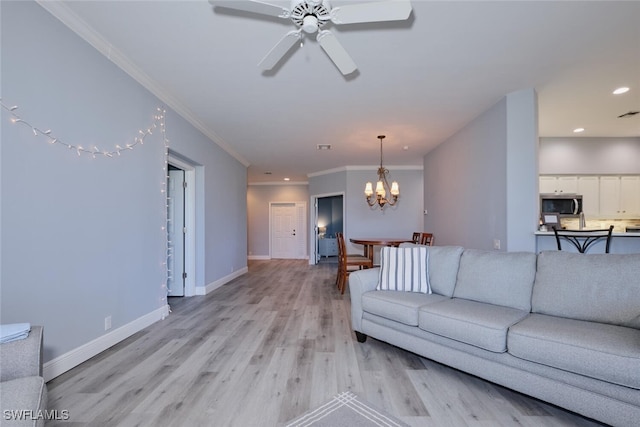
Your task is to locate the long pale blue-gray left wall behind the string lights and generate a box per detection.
[0,2,247,361]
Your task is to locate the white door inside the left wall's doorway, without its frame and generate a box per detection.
[167,169,185,297]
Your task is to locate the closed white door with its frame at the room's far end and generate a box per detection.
[269,202,307,259]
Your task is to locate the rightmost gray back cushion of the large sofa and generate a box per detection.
[532,251,640,329]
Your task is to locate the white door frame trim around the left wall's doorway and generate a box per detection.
[167,150,196,297]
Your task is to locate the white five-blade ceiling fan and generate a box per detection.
[209,0,411,75]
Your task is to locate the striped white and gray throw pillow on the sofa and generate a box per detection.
[376,246,431,294]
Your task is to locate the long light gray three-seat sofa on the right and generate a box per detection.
[349,246,640,426]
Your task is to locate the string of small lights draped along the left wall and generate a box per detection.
[0,98,173,320]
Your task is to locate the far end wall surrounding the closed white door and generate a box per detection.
[247,184,309,258]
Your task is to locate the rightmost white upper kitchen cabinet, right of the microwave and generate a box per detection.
[599,176,640,218]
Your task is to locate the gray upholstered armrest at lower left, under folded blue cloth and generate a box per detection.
[0,326,42,381]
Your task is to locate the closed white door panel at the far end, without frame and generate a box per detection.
[271,203,302,259]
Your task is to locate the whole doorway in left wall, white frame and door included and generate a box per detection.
[167,153,196,297]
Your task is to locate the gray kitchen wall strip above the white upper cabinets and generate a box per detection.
[540,139,640,175]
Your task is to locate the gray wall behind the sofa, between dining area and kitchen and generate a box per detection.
[424,90,537,251]
